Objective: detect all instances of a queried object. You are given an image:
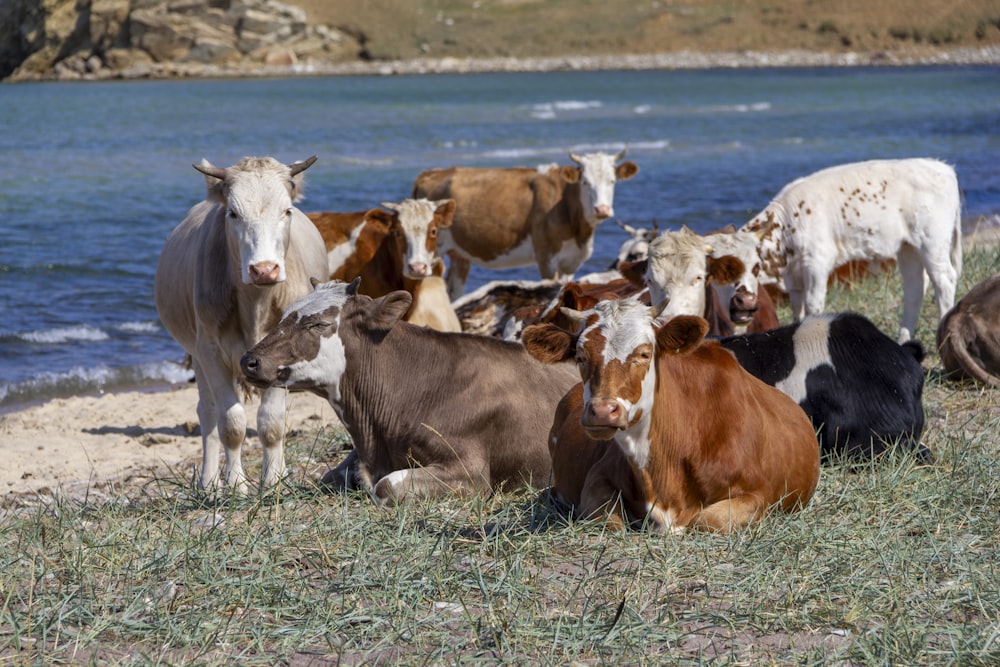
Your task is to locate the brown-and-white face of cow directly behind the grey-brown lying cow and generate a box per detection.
[382,199,455,279]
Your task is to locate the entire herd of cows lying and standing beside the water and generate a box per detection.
[155,151,1000,531]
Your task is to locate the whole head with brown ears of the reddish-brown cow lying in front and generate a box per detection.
[522,298,708,467]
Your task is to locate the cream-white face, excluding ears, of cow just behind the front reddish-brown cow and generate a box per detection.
[645,228,712,319]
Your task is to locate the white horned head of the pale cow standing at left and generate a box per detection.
[193,156,316,285]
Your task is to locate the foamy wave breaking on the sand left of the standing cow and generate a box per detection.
[0,361,193,408]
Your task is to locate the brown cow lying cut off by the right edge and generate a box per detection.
[937,274,1000,387]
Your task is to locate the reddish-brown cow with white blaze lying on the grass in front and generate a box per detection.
[522,299,819,532]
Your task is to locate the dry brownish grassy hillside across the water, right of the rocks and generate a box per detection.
[294,0,1000,59]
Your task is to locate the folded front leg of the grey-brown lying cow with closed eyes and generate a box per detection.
[371,462,490,505]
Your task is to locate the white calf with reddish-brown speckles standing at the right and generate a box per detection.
[742,158,962,343]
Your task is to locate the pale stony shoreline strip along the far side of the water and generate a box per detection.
[9,45,1000,83]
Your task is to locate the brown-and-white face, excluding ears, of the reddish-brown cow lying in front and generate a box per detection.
[570,298,658,468]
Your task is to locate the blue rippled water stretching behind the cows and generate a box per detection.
[0,67,1000,409]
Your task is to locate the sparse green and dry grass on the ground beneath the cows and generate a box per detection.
[0,247,1000,665]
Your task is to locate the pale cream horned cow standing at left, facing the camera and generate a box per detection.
[154,156,329,492]
